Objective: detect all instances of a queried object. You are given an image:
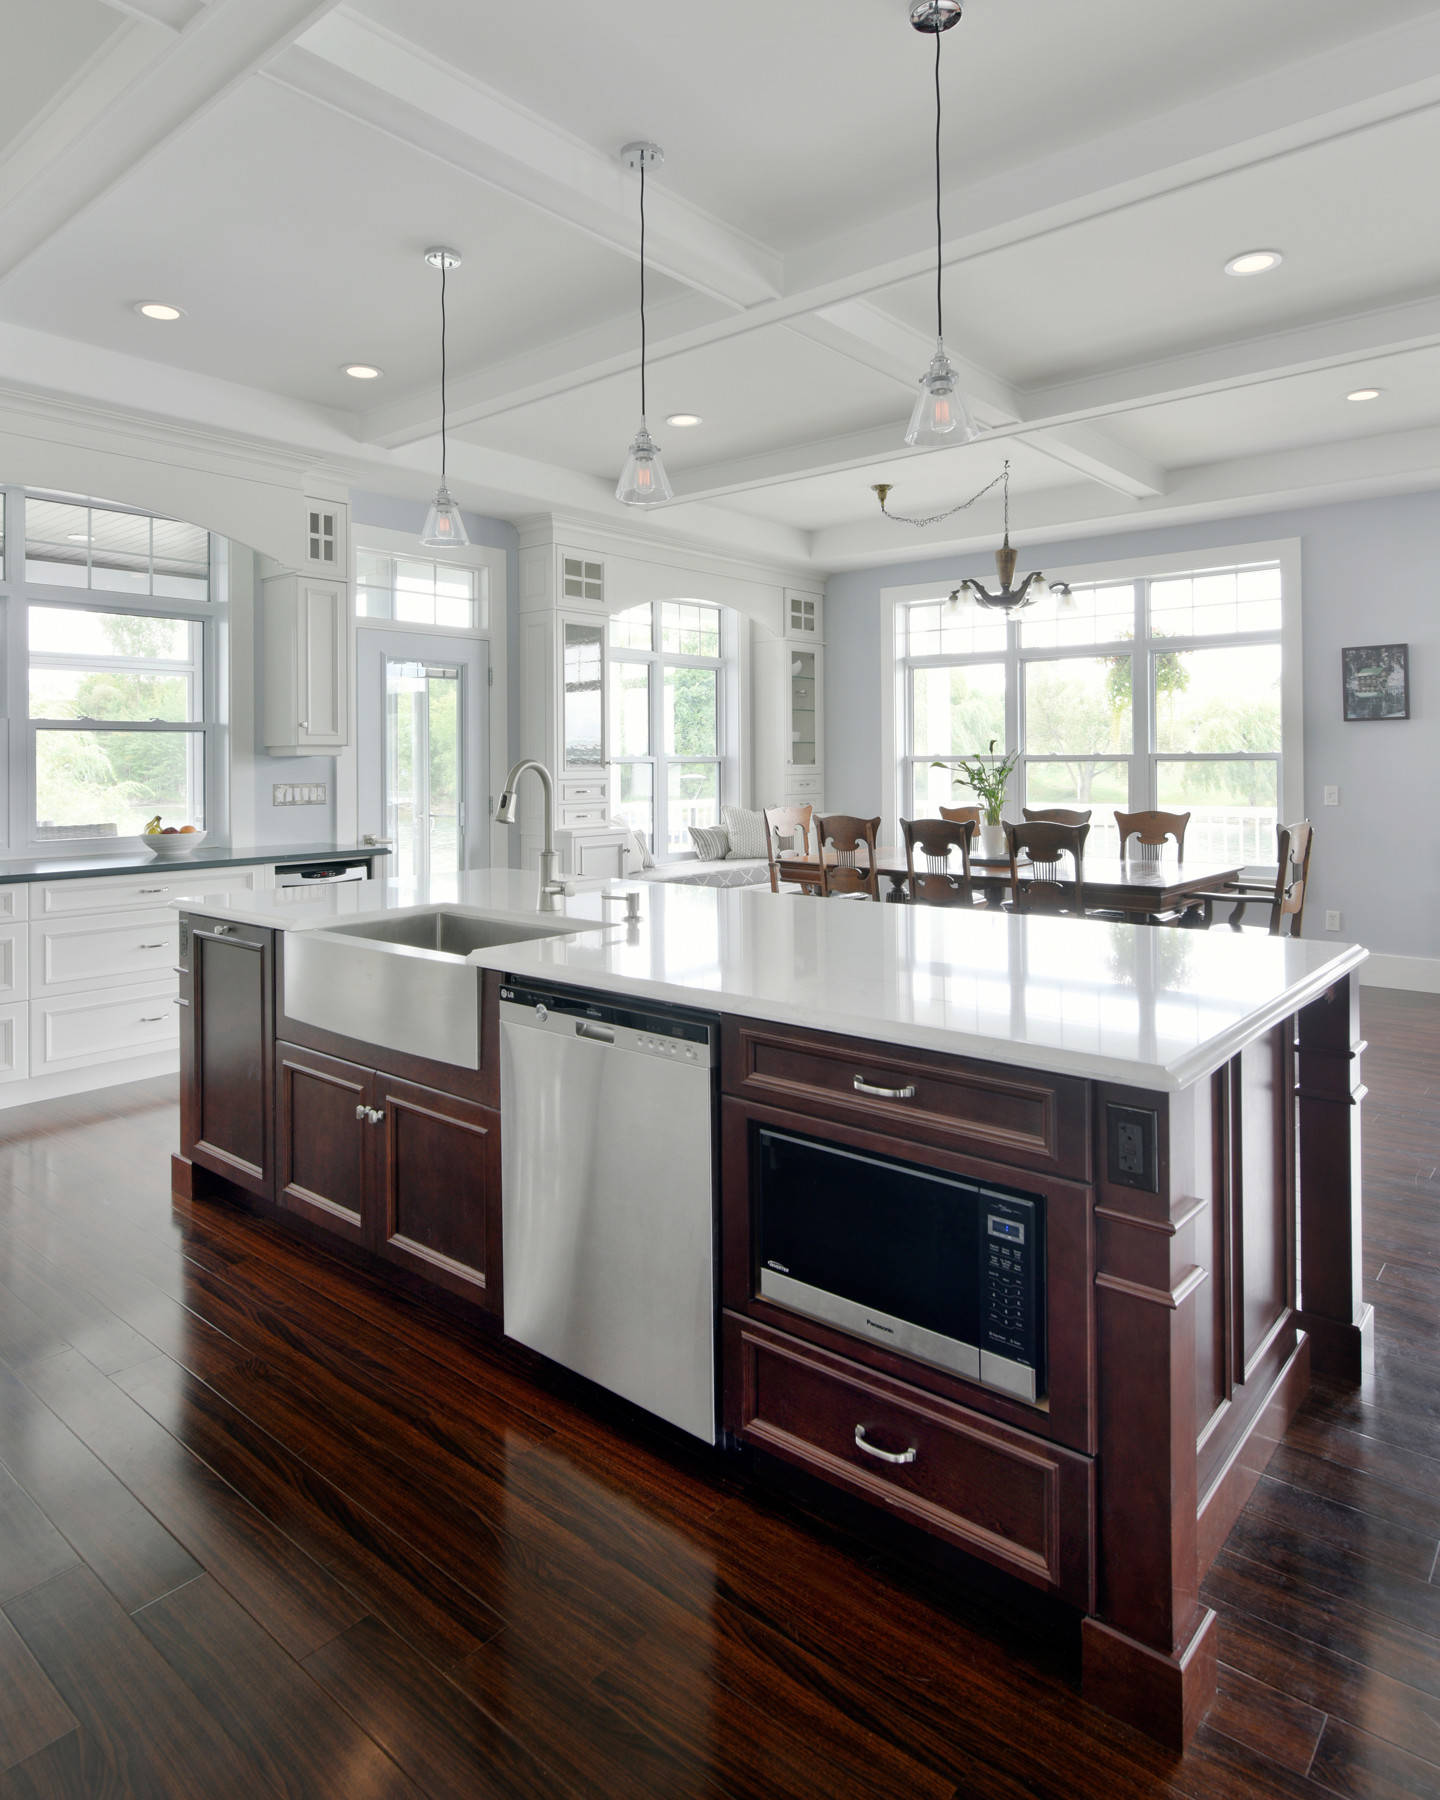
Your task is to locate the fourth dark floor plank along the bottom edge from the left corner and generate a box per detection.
[304,1618,579,1800]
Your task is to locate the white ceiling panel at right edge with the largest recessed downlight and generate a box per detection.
[877,108,1440,383]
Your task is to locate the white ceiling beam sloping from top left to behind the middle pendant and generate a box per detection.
[266,13,779,306]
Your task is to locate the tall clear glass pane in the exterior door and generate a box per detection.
[385,657,464,882]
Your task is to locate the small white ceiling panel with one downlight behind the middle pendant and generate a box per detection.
[459,326,911,475]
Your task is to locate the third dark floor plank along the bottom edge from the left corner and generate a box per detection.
[135,1575,419,1800]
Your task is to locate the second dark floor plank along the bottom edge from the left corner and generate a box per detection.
[5,1568,270,1800]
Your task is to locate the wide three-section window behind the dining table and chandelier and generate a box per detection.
[895,553,1300,862]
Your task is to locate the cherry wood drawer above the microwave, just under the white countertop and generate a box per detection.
[722,1019,1089,1179]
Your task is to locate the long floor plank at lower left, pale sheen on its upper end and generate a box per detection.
[19,1352,364,1656]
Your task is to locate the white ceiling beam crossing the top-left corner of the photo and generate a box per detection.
[0,0,335,277]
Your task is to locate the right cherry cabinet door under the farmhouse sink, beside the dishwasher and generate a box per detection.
[374,1075,500,1310]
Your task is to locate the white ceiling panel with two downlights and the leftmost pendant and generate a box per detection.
[0,81,691,407]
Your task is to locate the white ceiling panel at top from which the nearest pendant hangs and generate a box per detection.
[345,0,1433,250]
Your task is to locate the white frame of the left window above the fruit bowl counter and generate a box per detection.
[0,484,229,857]
